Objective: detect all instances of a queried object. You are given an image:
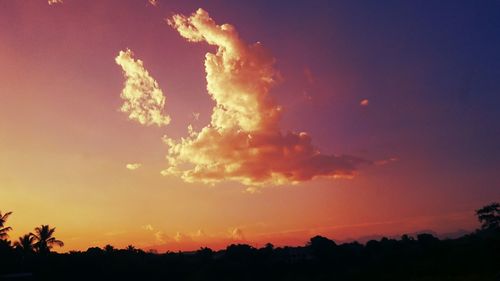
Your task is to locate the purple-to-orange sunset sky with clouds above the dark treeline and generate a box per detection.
[0,0,500,251]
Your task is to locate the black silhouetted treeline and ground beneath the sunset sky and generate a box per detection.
[0,203,500,281]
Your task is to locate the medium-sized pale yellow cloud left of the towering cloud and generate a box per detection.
[115,49,170,126]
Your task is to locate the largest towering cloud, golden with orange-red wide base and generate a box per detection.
[162,9,367,186]
